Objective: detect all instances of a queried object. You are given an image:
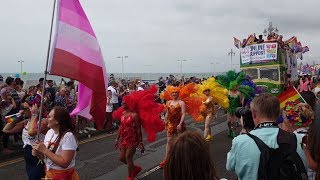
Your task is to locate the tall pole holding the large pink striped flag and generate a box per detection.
[37,0,57,141]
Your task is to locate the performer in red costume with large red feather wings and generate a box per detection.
[113,86,164,180]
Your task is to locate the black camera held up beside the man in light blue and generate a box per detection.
[235,107,255,131]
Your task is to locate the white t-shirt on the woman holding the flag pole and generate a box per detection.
[44,129,78,170]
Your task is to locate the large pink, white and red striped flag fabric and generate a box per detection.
[49,0,108,129]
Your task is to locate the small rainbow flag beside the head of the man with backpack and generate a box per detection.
[278,87,305,109]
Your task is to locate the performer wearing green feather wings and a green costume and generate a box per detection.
[217,71,254,138]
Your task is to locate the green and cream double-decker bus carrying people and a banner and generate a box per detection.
[234,23,309,95]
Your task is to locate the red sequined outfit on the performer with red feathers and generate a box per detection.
[119,114,139,148]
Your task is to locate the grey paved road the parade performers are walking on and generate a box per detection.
[0,109,235,180]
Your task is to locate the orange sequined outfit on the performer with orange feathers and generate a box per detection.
[166,103,186,136]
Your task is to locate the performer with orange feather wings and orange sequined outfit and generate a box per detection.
[160,83,202,167]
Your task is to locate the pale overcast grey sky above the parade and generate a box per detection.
[0,0,320,73]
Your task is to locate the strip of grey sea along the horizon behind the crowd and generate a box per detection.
[0,72,222,87]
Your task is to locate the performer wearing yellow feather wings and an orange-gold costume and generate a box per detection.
[197,77,229,141]
